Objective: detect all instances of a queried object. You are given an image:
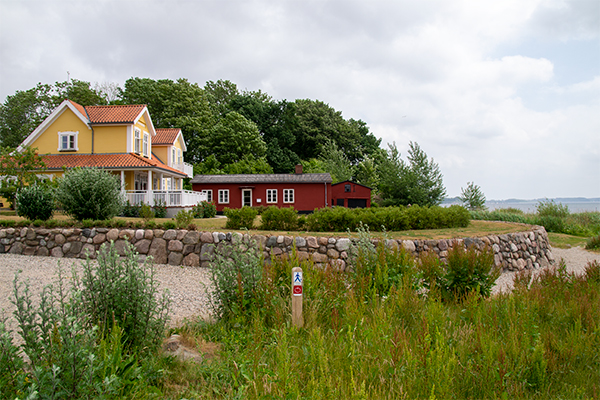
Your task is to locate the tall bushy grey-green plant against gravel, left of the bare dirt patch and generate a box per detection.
[75,243,169,352]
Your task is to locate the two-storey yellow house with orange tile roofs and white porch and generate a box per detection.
[19,100,205,207]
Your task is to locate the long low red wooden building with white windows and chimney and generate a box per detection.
[191,166,331,212]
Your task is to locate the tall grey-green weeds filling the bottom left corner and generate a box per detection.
[0,258,162,399]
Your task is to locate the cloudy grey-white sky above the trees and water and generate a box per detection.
[0,0,600,199]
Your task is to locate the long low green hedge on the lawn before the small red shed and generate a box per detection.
[306,206,469,232]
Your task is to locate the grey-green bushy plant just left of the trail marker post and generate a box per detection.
[210,238,262,320]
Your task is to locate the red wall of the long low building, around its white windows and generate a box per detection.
[192,182,331,212]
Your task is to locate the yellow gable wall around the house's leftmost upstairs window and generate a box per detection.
[30,109,92,154]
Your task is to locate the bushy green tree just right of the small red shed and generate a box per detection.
[377,142,446,206]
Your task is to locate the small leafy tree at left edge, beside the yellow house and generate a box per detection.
[0,147,46,208]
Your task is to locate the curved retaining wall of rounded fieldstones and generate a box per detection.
[0,226,554,270]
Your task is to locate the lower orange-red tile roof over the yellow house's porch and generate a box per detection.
[42,153,185,176]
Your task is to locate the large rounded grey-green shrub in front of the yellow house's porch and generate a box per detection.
[57,168,124,221]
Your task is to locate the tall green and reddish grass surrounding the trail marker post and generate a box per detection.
[159,238,600,399]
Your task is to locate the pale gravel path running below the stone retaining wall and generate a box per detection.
[0,247,600,338]
